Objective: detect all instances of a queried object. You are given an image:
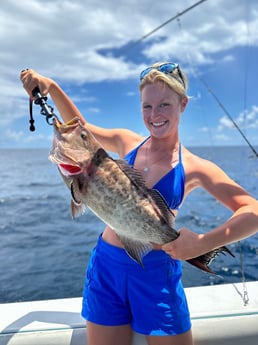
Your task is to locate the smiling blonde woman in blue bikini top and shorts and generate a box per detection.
[21,63,258,345]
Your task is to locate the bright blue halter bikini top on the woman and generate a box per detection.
[124,138,185,210]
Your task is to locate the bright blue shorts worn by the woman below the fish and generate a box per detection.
[82,236,191,335]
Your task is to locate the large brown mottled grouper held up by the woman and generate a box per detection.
[49,118,233,273]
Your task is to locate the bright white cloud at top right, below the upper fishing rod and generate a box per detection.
[141,0,258,64]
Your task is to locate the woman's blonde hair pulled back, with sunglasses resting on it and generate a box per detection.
[139,62,188,99]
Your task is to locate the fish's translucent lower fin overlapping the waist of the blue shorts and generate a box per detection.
[118,235,152,266]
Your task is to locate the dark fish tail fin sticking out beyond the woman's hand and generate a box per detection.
[187,246,235,274]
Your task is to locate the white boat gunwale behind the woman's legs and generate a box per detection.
[0,281,258,345]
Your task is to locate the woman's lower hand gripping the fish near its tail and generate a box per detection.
[162,228,207,260]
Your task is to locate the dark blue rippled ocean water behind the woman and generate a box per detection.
[0,147,258,303]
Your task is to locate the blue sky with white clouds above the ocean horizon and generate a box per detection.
[0,0,258,148]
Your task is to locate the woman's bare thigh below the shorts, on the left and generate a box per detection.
[87,321,132,345]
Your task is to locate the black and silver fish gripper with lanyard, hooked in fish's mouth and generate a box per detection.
[29,86,59,132]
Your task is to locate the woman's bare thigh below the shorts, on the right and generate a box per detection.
[146,330,193,345]
